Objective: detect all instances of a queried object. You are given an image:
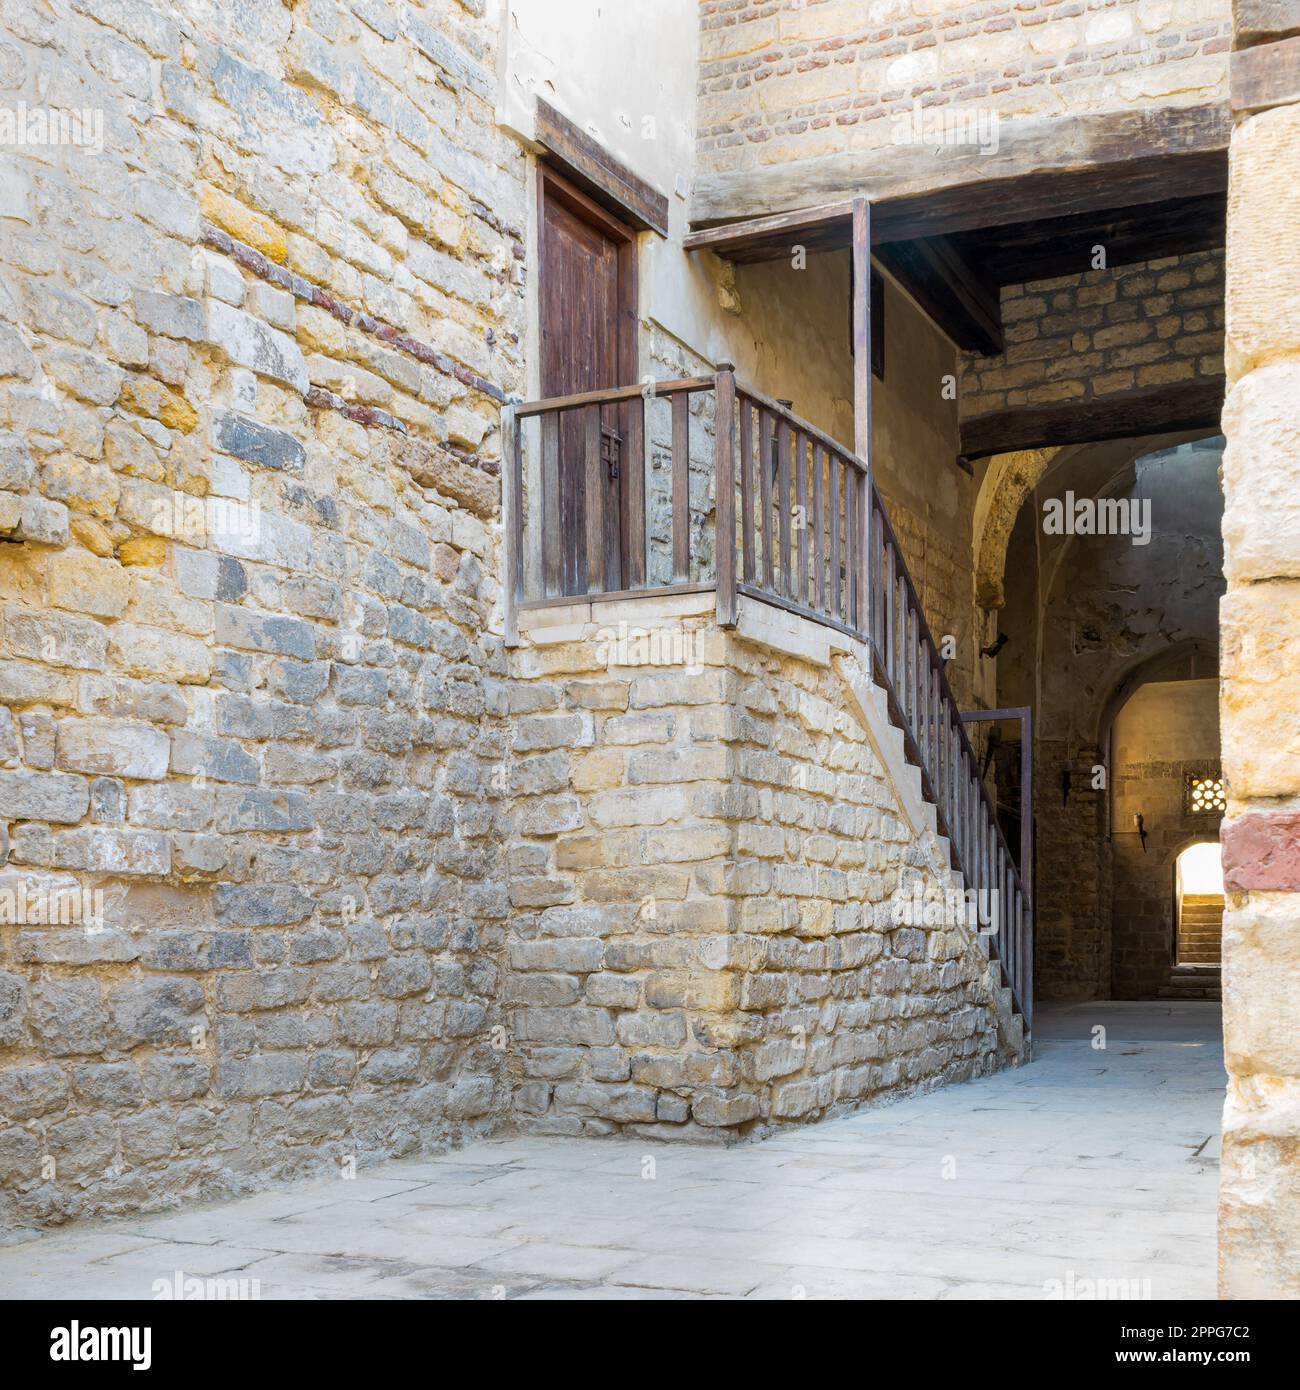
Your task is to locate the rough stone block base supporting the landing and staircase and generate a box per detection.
[506,598,1011,1138]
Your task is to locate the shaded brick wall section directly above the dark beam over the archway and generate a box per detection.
[959,250,1224,417]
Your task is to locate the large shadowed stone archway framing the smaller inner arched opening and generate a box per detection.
[977,435,1224,999]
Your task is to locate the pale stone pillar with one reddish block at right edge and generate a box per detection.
[1219,0,1300,1298]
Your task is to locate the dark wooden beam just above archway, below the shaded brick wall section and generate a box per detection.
[961,377,1224,460]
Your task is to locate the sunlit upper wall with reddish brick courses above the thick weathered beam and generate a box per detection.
[697,0,1232,177]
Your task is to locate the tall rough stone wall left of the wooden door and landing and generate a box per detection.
[0,0,524,1223]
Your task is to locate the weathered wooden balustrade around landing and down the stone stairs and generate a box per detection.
[506,364,1033,1026]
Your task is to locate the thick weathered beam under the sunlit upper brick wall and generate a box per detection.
[691,106,1232,233]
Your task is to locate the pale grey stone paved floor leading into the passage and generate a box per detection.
[0,1004,1224,1298]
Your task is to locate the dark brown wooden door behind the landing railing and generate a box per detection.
[538,167,637,594]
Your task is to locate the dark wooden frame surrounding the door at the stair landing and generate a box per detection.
[537,161,645,589]
